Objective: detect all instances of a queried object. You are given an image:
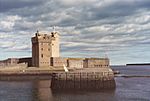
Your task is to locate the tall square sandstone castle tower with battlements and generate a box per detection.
[32,31,59,67]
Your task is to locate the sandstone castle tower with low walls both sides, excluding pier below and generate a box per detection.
[0,31,109,68]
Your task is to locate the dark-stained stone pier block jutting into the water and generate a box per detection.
[51,72,116,90]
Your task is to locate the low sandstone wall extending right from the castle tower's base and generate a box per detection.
[50,57,109,68]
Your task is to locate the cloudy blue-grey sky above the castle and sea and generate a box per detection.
[0,0,150,65]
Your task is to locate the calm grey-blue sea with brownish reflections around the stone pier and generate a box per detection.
[0,66,150,101]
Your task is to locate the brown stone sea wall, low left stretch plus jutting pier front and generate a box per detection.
[0,70,116,90]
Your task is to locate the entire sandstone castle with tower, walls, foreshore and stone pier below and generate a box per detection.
[0,31,116,91]
